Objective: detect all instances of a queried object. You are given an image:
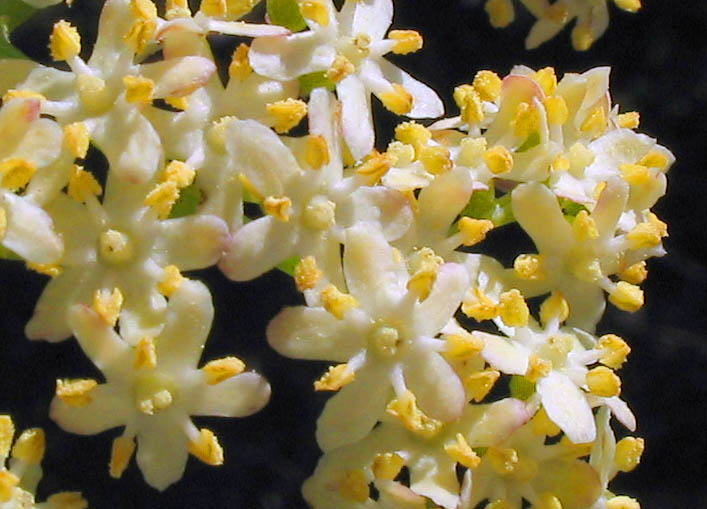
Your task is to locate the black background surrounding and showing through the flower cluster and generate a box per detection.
[0,0,707,509]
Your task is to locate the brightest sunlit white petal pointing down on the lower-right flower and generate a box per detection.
[536,371,597,444]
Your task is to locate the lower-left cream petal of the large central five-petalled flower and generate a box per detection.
[317,366,392,452]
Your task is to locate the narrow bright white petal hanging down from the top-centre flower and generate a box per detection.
[336,75,375,161]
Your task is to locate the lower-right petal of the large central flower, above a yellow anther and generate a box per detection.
[403,350,466,422]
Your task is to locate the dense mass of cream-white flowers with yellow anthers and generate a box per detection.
[0,0,674,509]
